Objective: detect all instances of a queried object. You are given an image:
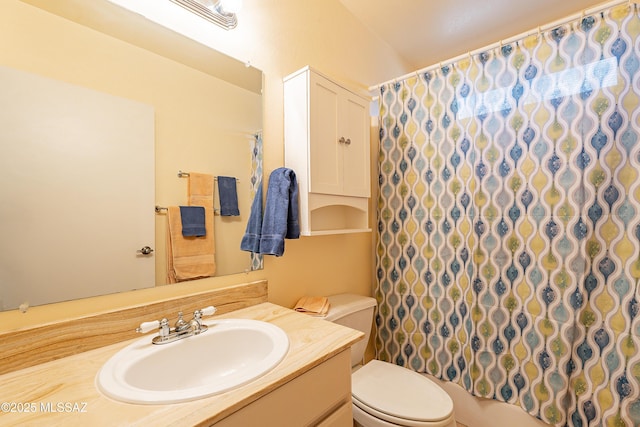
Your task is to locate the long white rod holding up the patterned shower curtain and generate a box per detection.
[369,0,638,92]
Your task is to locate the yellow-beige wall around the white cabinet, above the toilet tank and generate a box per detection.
[211,0,409,306]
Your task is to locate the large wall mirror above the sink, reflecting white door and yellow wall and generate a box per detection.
[0,0,262,310]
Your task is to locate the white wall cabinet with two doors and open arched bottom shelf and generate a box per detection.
[284,67,371,236]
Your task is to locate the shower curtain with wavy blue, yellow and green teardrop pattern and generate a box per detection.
[376,2,640,427]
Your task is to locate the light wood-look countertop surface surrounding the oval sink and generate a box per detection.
[0,303,363,427]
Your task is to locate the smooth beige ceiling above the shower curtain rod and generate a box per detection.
[340,0,616,71]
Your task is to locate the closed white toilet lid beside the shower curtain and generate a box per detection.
[351,360,453,422]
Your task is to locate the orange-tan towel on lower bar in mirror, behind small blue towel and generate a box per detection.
[167,206,216,283]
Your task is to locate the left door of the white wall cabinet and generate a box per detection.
[309,73,343,194]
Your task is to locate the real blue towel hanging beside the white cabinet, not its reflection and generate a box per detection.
[259,168,300,256]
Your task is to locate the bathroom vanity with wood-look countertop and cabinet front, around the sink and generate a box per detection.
[0,302,363,427]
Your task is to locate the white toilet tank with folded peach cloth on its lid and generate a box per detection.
[325,294,376,367]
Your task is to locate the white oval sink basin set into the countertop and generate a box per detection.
[96,319,289,404]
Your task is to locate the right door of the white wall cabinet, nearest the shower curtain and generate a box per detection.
[338,91,371,197]
